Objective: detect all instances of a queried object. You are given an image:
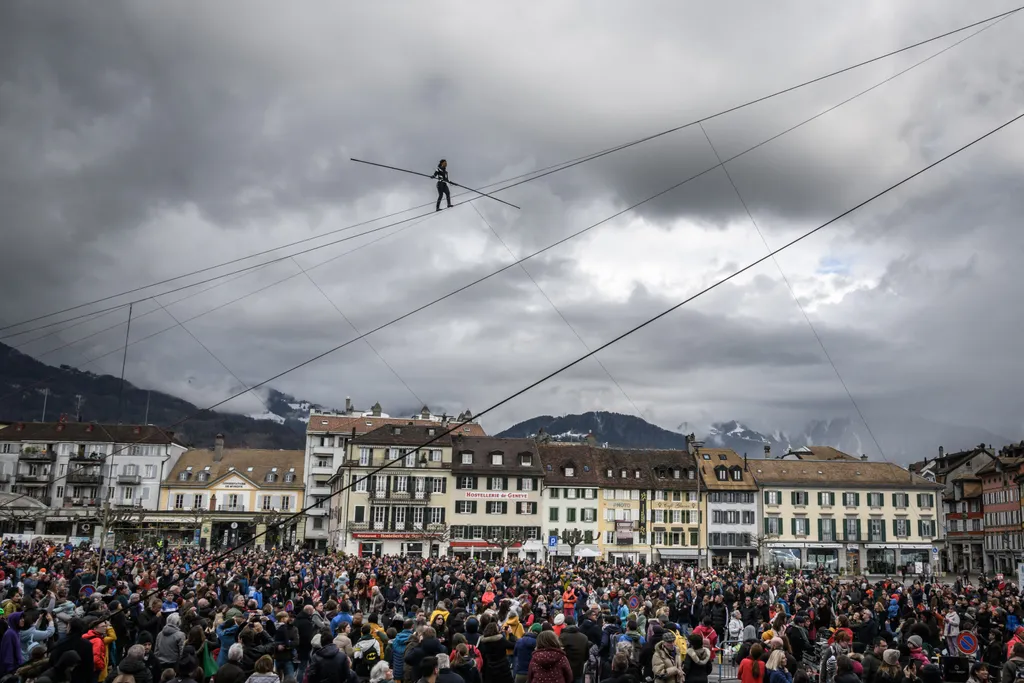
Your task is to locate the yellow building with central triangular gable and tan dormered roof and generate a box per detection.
[156,434,305,548]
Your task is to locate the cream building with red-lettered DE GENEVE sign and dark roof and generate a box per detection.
[450,436,544,560]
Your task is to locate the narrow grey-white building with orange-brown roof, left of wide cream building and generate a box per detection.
[696,447,759,568]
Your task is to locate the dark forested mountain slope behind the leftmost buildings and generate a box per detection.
[0,344,310,449]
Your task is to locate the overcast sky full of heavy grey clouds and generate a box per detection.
[0,0,1024,458]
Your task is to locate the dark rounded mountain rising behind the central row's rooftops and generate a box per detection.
[497,411,686,449]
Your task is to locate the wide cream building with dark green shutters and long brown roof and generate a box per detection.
[749,457,942,574]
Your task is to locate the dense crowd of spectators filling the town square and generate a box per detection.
[0,543,1024,683]
